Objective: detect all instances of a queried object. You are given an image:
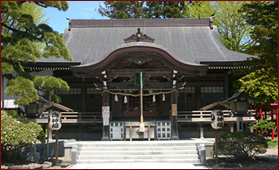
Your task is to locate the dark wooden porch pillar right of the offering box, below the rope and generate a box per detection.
[171,91,179,140]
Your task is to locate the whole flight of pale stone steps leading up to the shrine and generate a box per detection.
[74,141,200,164]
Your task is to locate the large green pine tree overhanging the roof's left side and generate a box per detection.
[1,1,72,105]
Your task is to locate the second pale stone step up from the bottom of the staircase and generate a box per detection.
[78,154,198,160]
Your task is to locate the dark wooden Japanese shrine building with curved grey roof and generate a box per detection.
[24,18,255,140]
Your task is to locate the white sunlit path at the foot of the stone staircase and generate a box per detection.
[69,163,208,169]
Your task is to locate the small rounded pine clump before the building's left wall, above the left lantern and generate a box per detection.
[34,76,70,103]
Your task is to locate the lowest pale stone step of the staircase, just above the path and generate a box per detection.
[77,158,200,164]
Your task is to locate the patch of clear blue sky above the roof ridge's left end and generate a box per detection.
[44,1,108,33]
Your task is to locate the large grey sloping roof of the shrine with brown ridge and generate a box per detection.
[37,18,255,69]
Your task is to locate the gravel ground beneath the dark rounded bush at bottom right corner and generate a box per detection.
[205,146,278,169]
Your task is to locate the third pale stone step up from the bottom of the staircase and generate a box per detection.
[77,148,197,155]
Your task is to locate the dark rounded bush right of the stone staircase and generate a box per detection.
[213,131,268,160]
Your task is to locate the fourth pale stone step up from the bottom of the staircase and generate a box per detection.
[77,146,196,151]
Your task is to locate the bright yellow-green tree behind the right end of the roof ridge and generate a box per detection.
[184,1,253,52]
